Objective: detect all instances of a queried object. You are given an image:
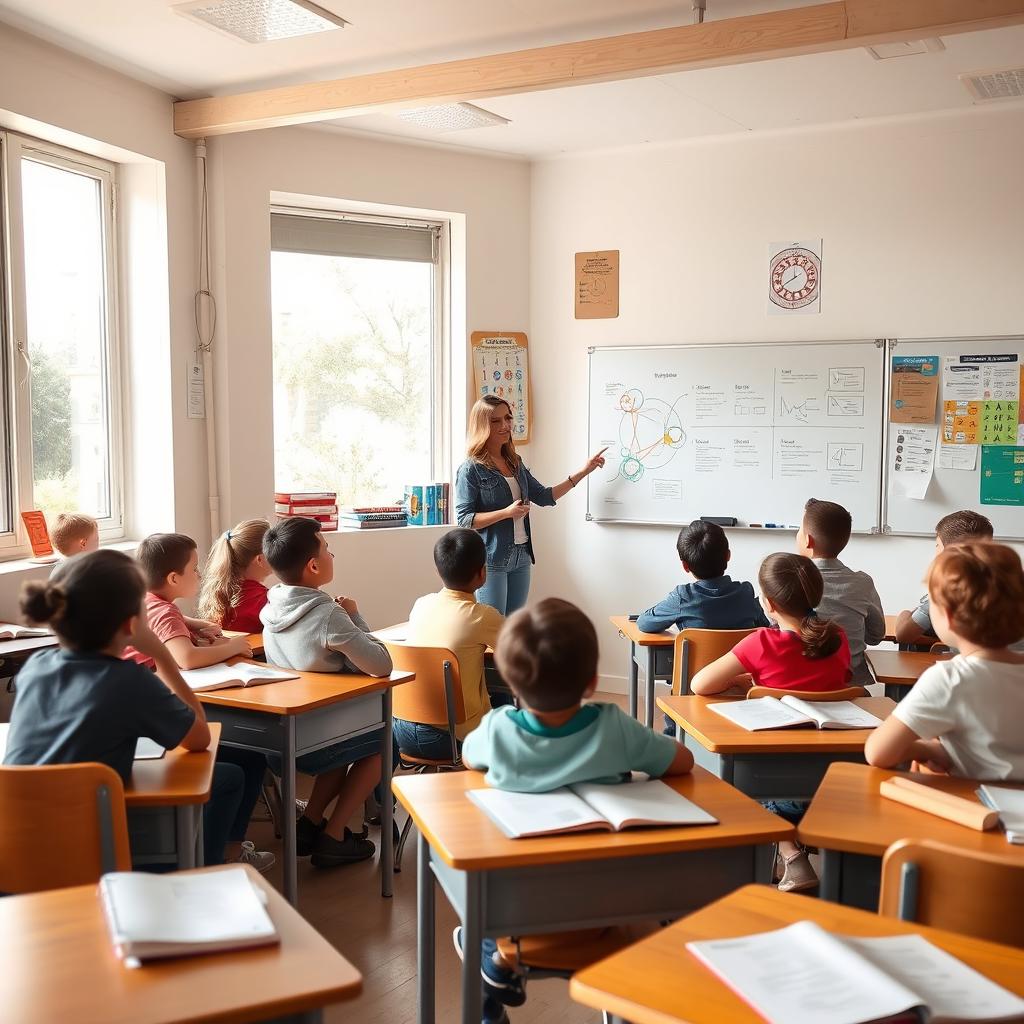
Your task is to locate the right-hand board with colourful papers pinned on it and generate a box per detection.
[882,336,1024,541]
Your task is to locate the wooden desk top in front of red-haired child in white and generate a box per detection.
[799,764,1024,865]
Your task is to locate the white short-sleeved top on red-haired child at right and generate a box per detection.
[893,654,1024,781]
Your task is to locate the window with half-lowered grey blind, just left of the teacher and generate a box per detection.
[271,211,445,506]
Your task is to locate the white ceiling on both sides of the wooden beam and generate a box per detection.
[0,0,1024,157]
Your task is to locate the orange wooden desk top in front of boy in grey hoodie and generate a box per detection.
[196,659,416,715]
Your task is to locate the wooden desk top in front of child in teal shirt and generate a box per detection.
[391,768,793,870]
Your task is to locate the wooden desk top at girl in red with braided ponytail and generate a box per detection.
[657,691,896,754]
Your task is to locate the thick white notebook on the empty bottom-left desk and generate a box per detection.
[99,867,280,966]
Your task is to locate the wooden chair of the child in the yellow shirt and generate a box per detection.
[385,641,466,871]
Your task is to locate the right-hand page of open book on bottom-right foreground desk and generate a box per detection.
[844,935,1024,1021]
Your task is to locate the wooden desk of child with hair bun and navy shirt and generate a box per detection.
[0,722,220,868]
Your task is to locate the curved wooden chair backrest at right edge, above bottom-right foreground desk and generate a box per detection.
[879,839,1024,946]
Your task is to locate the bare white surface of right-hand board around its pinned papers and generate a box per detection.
[883,337,1024,540]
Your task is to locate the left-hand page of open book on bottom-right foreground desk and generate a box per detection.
[686,921,921,1024]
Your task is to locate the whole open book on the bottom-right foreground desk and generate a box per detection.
[686,921,1024,1024]
